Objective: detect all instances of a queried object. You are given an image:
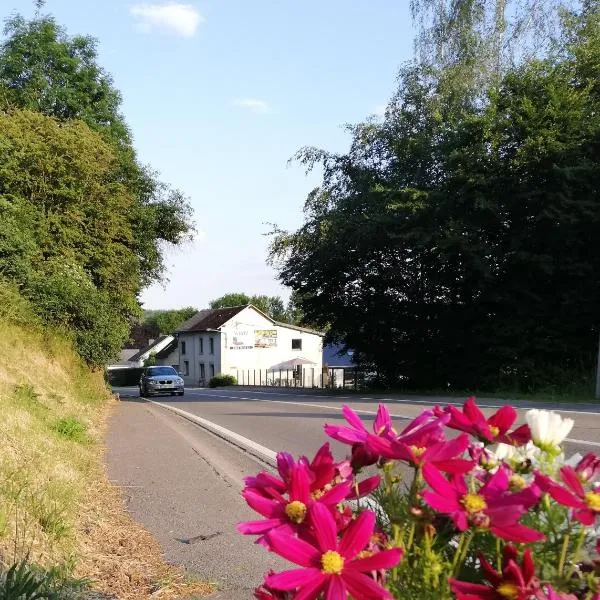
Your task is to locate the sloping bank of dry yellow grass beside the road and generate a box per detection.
[0,321,211,599]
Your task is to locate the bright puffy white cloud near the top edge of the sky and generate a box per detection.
[129,2,204,37]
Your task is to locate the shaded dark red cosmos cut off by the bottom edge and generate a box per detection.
[449,545,540,600]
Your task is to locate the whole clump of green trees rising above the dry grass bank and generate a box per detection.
[0,6,193,366]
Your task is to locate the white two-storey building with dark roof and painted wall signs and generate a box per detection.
[169,304,323,387]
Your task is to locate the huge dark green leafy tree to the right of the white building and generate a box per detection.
[271,2,600,389]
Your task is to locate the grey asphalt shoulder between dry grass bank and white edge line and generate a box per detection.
[106,399,285,600]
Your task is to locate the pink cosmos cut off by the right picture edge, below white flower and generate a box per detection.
[535,467,600,525]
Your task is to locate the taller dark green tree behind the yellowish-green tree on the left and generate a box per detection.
[0,9,193,286]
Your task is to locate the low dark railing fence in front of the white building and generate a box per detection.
[237,368,364,389]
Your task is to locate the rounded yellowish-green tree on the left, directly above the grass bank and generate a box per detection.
[0,110,140,365]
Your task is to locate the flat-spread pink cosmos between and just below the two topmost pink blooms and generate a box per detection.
[370,434,476,474]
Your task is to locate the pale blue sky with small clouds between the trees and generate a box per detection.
[0,0,414,309]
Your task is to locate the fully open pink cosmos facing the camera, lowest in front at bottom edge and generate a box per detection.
[265,504,402,600]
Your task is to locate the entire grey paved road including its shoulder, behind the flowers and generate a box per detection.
[107,388,600,600]
